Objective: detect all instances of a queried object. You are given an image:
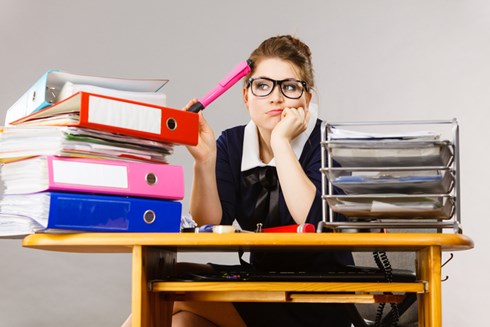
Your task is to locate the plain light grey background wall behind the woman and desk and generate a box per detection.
[0,0,490,327]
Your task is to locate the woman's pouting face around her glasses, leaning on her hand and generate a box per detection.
[243,58,311,132]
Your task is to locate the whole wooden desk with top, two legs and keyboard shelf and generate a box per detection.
[23,233,473,327]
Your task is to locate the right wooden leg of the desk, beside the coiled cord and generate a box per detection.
[417,246,442,327]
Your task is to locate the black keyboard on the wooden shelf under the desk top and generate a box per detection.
[170,266,416,282]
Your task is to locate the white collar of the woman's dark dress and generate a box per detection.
[241,103,320,171]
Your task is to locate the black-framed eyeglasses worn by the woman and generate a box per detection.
[247,77,308,99]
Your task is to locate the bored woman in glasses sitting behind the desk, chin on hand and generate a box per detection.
[173,35,352,327]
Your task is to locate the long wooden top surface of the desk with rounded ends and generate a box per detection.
[22,233,473,253]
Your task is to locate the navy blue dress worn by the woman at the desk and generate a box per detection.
[216,120,353,327]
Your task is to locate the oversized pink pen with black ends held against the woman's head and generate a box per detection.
[187,59,252,113]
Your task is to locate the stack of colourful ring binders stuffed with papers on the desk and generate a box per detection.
[0,71,198,236]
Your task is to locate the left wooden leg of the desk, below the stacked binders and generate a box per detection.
[131,245,175,327]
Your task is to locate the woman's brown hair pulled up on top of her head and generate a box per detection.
[244,35,315,87]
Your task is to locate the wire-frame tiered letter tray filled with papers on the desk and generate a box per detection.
[321,119,461,232]
